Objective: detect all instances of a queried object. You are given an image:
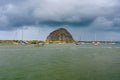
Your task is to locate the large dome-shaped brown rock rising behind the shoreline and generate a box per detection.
[46,28,74,42]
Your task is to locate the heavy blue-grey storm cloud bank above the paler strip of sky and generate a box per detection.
[0,0,120,30]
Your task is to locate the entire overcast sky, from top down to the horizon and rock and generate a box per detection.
[0,0,120,41]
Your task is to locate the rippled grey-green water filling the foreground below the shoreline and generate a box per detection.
[0,44,120,80]
